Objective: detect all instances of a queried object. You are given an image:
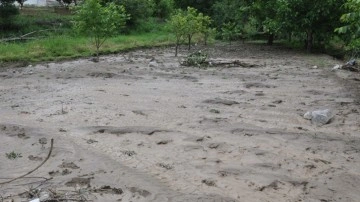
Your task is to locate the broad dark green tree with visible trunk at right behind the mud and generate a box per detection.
[276,0,345,52]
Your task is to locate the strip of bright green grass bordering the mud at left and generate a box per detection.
[0,32,173,63]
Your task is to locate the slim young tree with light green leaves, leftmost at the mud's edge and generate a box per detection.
[74,0,129,60]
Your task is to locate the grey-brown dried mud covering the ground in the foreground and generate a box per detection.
[0,44,360,202]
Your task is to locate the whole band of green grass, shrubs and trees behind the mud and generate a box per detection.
[0,0,360,63]
